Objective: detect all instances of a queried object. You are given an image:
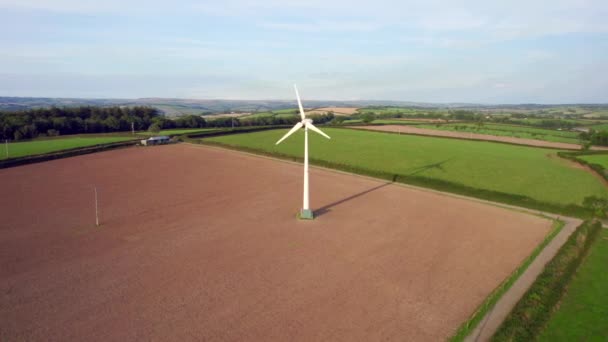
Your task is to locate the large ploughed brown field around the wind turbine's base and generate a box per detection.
[0,144,551,341]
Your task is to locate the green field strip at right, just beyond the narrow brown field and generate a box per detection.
[419,123,580,144]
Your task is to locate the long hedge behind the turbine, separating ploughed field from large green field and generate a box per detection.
[194,138,593,219]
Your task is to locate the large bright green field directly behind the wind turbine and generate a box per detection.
[208,128,608,204]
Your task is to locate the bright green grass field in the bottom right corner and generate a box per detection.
[539,229,608,341]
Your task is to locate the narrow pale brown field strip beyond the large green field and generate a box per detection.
[352,125,608,150]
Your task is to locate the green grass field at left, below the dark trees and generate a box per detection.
[0,137,133,159]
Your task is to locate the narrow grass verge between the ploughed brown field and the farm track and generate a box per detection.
[450,219,565,341]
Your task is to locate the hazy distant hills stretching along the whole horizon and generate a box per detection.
[0,97,608,116]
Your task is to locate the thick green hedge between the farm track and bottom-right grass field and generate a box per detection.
[492,221,602,341]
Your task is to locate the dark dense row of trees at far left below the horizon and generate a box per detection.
[0,106,160,140]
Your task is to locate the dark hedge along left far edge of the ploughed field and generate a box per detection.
[0,140,139,169]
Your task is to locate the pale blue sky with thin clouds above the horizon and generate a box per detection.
[0,0,608,103]
